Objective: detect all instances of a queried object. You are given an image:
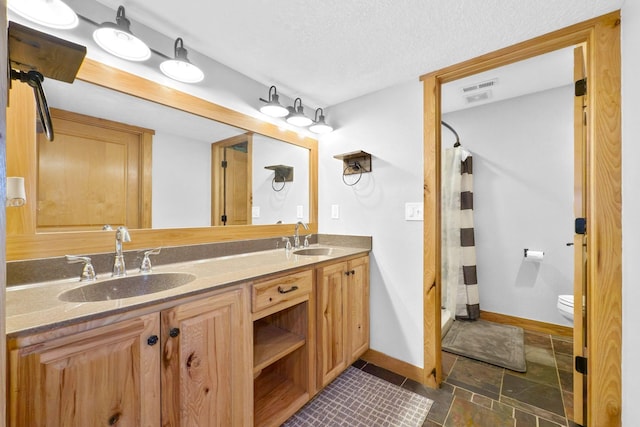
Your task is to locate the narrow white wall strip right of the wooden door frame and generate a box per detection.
[622,0,640,427]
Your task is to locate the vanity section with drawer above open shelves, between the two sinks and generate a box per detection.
[252,270,315,427]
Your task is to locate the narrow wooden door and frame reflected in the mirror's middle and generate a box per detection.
[211,133,253,225]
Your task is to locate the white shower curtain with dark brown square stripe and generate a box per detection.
[441,147,480,320]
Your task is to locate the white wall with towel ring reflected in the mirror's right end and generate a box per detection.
[252,135,309,226]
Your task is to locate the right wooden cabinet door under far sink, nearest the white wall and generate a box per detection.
[345,256,369,363]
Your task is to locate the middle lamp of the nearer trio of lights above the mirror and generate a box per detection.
[93,6,151,61]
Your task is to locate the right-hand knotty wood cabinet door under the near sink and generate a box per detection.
[161,290,253,427]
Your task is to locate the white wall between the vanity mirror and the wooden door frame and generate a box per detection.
[318,78,423,366]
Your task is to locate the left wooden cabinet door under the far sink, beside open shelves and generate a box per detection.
[317,262,347,387]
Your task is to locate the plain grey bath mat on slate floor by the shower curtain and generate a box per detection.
[442,320,527,372]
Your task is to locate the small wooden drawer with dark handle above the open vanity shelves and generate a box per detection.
[251,270,313,312]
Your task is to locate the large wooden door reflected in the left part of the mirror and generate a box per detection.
[36,109,154,231]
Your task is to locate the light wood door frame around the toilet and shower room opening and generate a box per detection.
[420,11,622,426]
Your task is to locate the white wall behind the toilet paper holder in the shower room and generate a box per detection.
[443,85,574,325]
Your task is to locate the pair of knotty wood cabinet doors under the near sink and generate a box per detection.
[9,288,252,427]
